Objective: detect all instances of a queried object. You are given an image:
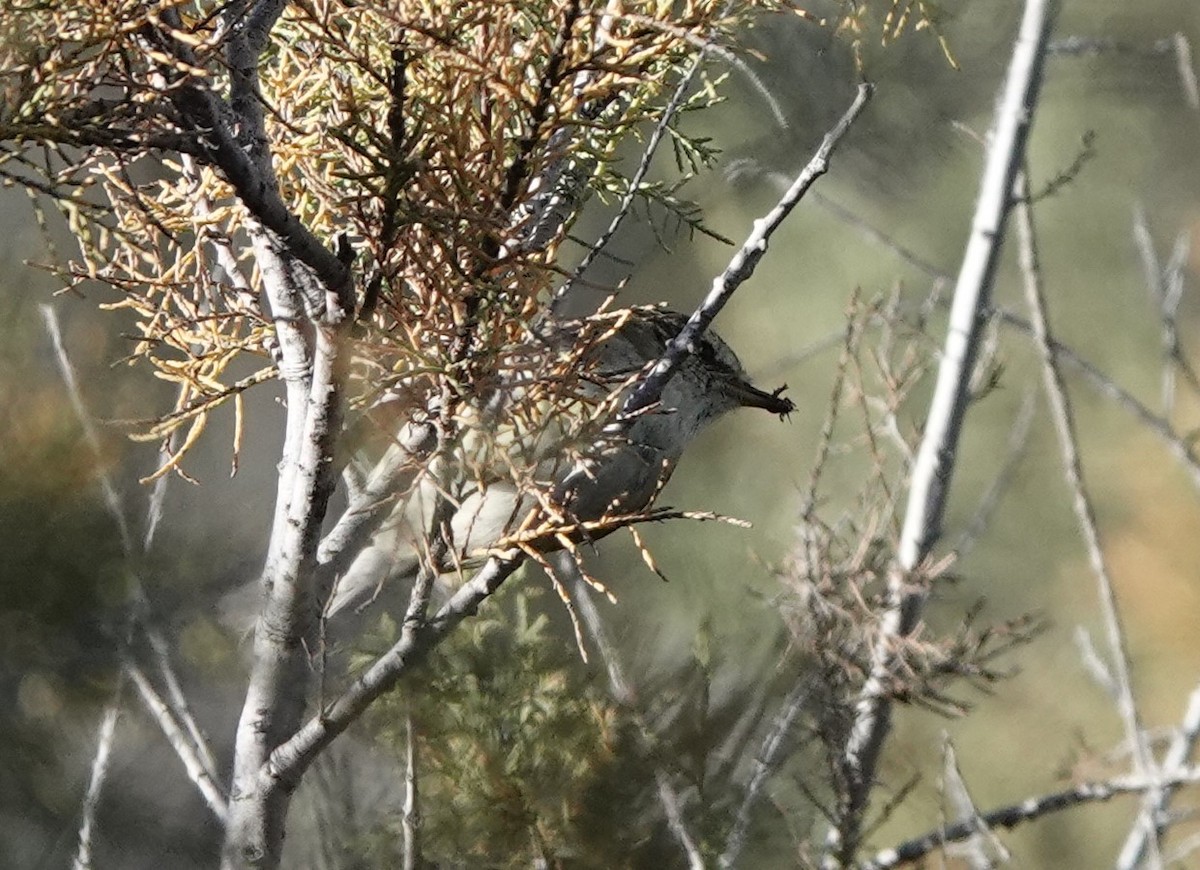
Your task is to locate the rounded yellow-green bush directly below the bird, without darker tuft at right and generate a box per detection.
[371,589,622,866]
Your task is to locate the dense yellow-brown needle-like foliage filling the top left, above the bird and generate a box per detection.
[0,0,792,475]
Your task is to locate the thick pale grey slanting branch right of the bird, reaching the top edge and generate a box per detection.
[824,0,1057,866]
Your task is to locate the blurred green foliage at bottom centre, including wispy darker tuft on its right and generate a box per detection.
[355,586,806,868]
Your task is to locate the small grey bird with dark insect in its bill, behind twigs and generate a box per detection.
[325,307,794,617]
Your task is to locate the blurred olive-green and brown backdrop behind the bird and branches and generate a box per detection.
[0,0,1200,868]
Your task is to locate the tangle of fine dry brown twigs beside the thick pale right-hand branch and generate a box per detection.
[768,298,1043,868]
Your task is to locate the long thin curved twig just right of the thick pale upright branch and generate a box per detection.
[1014,173,1162,868]
